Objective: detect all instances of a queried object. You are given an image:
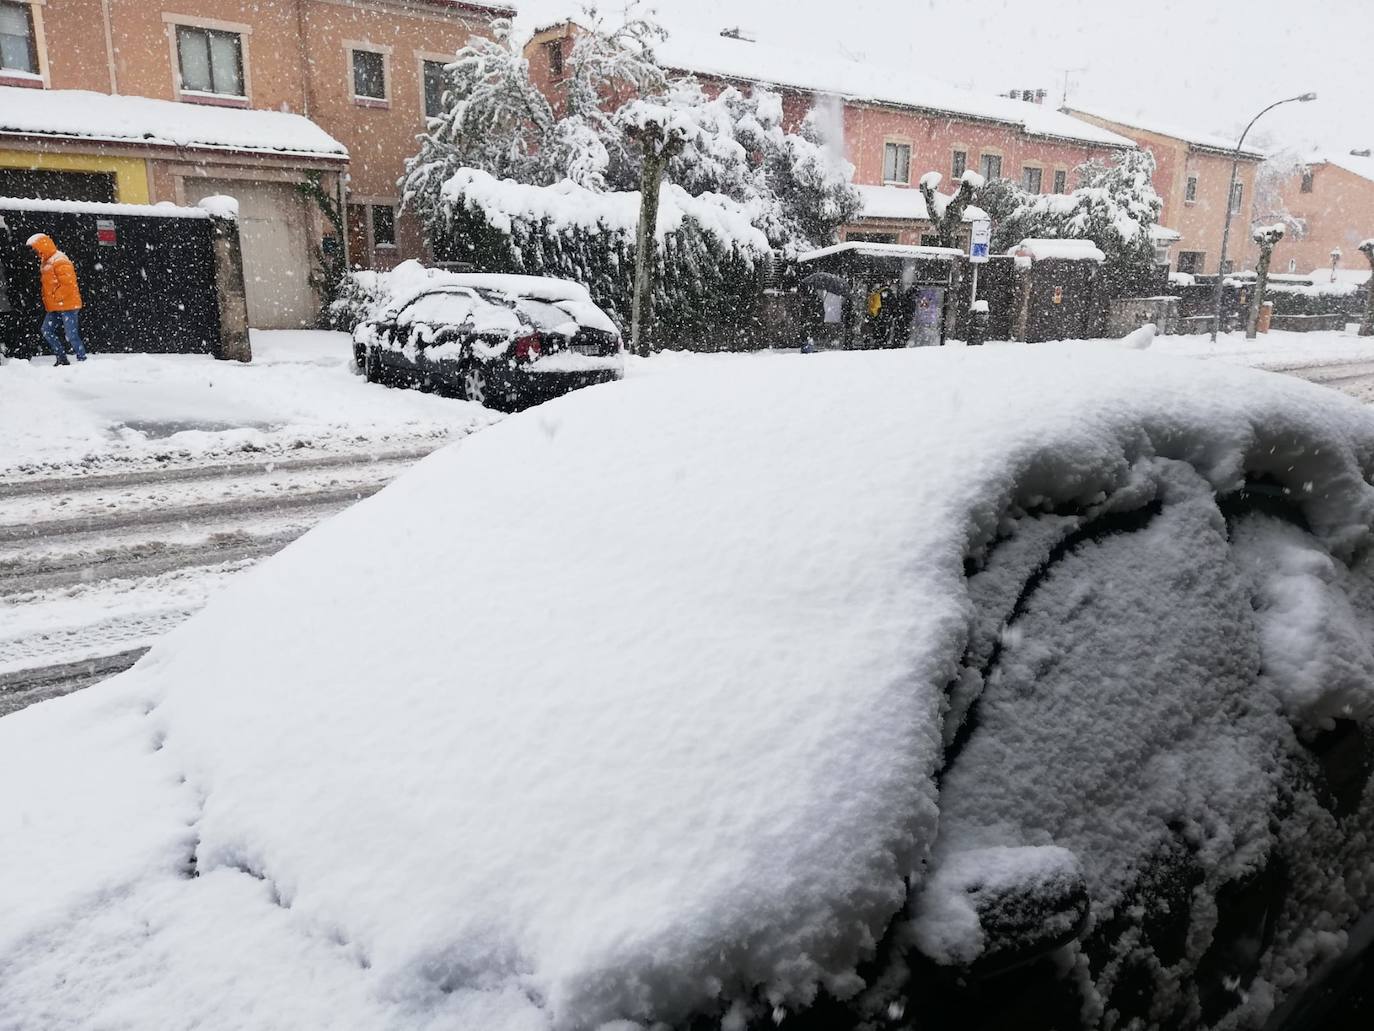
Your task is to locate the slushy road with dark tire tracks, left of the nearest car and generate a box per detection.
[0,445,433,716]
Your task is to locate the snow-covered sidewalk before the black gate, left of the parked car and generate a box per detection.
[0,331,497,477]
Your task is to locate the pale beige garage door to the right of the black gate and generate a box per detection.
[185,179,319,330]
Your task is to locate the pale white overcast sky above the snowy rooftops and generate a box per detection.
[517,0,1374,157]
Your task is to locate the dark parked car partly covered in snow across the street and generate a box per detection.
[353,274,624,410]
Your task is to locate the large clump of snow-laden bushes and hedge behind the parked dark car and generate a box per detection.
[401,10,860,344]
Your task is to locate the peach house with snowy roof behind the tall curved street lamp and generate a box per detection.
[1069,109,1264,274]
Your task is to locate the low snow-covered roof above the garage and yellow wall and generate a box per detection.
[0,87,348,159]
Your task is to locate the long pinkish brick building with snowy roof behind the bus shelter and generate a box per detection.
[525,21,1135,243]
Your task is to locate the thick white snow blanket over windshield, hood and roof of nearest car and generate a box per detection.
[8,344,1374,1030]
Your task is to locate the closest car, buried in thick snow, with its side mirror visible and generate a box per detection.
[0,345,1374,1031]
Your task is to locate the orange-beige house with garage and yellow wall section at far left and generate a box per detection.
[0,0,514,327]
